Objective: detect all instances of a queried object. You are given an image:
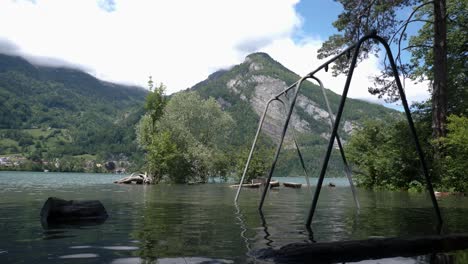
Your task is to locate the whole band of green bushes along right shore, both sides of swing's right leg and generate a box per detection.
[346,114,468,192]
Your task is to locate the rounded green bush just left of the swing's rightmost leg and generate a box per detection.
[346,118,430,189]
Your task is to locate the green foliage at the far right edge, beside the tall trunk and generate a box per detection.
[440,115,468,192]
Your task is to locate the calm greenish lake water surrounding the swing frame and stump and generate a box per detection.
[0,172,468,264]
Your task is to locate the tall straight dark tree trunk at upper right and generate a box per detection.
[432,0,448,139]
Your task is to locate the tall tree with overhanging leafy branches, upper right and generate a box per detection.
[318,0,454,138]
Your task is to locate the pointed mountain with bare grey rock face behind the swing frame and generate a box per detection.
[192,53,398,144]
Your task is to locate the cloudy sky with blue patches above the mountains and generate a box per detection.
[0,0,428,103]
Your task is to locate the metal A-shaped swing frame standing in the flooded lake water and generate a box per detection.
[235,31,443,229]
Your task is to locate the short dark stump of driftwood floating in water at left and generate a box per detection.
[41,197,108,228]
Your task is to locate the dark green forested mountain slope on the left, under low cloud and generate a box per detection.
[0,54,147,169]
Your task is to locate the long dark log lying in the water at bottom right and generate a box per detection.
[254,234,468,263]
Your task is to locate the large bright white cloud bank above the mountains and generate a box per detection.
[0,0,300,92]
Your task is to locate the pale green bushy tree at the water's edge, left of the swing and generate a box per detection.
[137,92,232,183]
